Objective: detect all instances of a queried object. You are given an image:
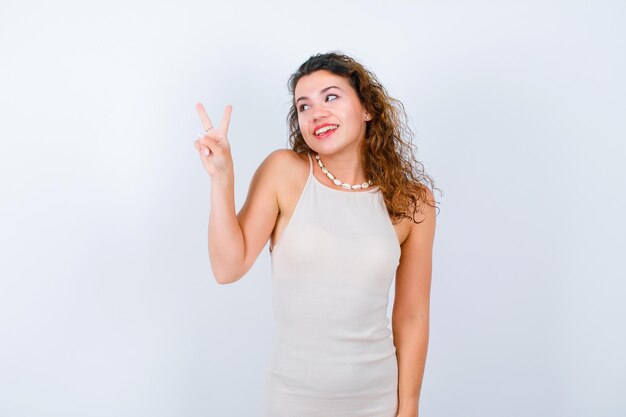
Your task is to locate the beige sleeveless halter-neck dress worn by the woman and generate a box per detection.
[263,153,400,417]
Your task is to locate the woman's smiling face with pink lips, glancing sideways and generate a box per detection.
[294,70,371,154]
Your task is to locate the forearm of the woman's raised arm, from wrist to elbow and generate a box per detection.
[209,169,244,284]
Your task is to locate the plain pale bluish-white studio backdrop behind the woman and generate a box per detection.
[0,1,626,417]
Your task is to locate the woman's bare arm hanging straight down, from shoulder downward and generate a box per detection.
[392,192,436,417]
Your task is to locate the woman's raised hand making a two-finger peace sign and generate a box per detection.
[194,103,233,178]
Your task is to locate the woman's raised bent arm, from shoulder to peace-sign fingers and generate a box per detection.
[195,104,282,284]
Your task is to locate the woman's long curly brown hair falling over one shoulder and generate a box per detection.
[287,51,441,224]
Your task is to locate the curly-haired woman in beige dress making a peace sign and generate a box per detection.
[195,52,436,417]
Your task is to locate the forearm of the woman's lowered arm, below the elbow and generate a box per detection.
[392,315,429,417]
